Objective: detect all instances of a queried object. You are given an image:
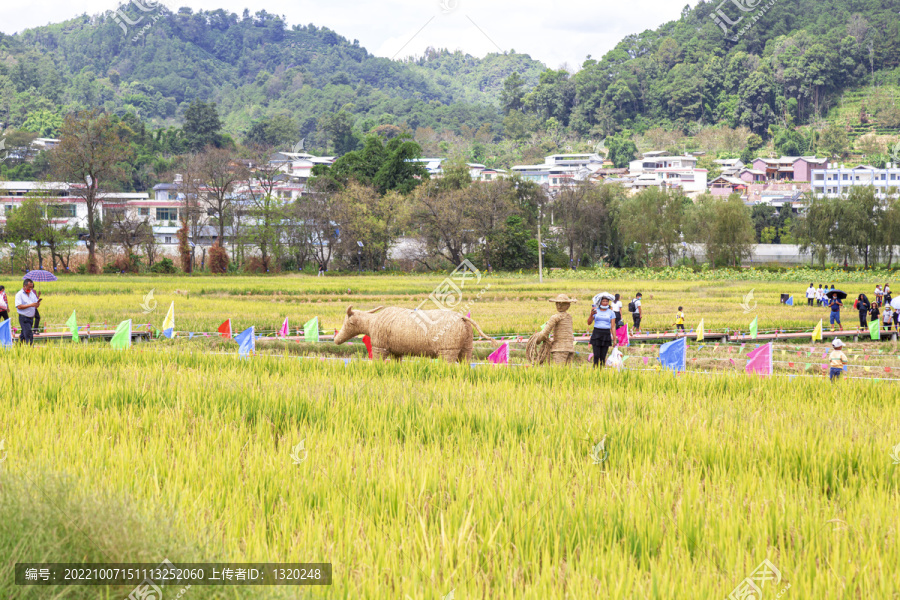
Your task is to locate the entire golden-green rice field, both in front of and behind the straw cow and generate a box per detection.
[0,277,900,600]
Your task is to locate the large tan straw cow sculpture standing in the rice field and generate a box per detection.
[334,306,499,363]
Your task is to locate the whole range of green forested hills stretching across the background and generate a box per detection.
[0,0,900,157]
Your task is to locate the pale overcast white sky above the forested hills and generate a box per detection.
[0,0,693,70]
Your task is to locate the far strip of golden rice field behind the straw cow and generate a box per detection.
[10,275,900,334]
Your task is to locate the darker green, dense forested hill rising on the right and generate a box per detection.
[524,0,900,136]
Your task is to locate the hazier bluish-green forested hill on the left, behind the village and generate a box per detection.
[0,5,545,141]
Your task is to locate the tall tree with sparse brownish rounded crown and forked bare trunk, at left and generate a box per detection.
[50,111,133,273]
